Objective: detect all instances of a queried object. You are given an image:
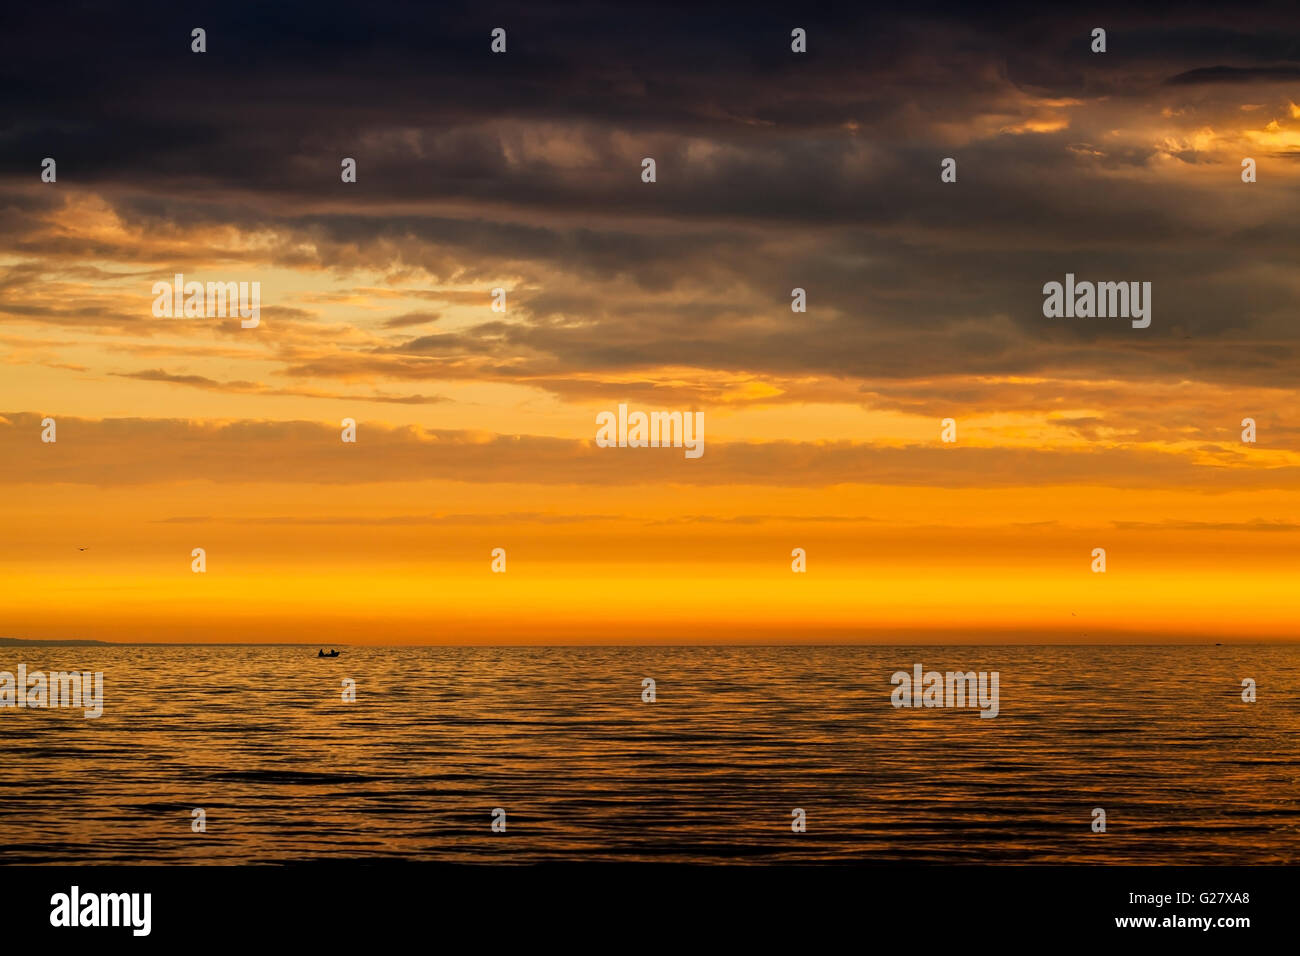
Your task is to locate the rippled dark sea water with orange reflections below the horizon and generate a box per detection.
[0,645,1300,864]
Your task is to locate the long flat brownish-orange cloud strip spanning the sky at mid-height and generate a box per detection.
[0,412,1300,492]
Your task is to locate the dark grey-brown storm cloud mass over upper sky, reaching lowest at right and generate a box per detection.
[0,3,1300,394]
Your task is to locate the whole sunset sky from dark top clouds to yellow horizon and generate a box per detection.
[0,3,1300,644]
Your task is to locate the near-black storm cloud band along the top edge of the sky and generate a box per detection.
[0,3,1297,191]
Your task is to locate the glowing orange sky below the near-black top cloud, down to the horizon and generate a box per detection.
[0,31,1300,644]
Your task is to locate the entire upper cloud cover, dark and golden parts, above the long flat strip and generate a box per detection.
[0,3,1300,468]
